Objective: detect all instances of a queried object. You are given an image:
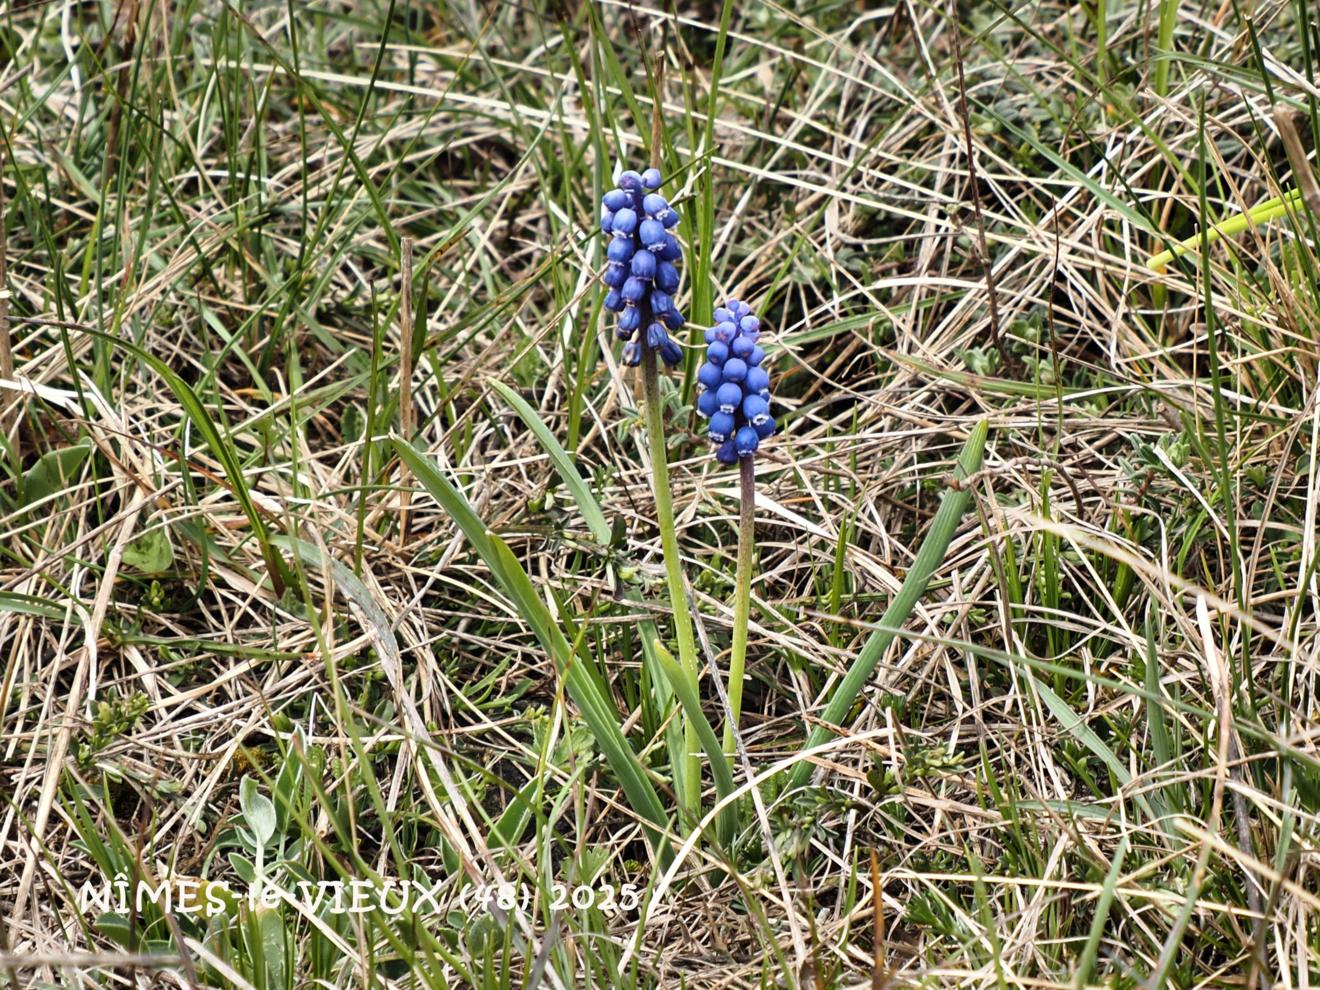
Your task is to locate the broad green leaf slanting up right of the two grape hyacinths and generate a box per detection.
[788,420,990,789]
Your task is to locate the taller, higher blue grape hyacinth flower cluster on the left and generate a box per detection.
[601,169,684,367]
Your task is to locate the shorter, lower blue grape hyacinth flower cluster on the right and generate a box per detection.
[697,300,775,465]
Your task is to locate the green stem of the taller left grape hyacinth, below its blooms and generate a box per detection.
[642,347,701,821]
